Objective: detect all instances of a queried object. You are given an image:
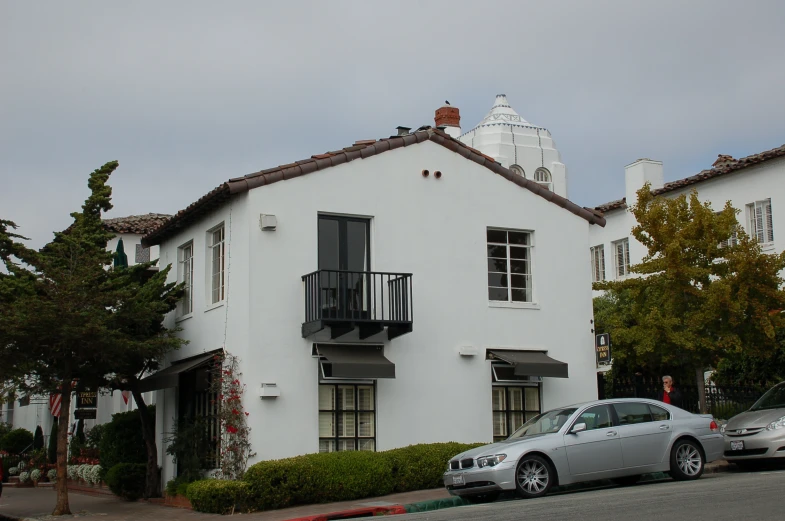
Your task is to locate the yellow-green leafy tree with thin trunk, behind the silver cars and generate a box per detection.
[594,184,785,411]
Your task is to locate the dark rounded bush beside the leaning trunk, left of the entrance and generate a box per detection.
[99,405,155,485]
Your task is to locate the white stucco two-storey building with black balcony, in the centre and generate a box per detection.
[139,121,604,481]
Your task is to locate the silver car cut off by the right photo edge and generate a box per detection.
[721,382,785,466]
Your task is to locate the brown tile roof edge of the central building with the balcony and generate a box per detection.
[142,127,605,246]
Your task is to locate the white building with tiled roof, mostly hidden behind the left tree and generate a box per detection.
[0,213,171,437]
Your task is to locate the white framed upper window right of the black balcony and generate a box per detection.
[487,228,533,302]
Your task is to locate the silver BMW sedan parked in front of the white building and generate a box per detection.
[444,398,723,500]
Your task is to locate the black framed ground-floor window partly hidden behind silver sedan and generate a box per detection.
[492,384,541,441]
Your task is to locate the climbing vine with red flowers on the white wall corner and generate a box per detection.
[211,353,256,479]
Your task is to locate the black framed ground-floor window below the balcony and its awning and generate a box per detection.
[319,383,376,452]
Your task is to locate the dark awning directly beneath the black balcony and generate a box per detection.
[316,344,395,378]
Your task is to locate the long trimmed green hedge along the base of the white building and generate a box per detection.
[243,443,482,510]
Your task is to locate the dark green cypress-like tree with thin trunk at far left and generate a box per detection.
[0,161,182,515]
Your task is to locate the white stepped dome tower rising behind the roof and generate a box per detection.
[458,94,567,197]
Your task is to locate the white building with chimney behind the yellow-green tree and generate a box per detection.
[589,145,785,372]
